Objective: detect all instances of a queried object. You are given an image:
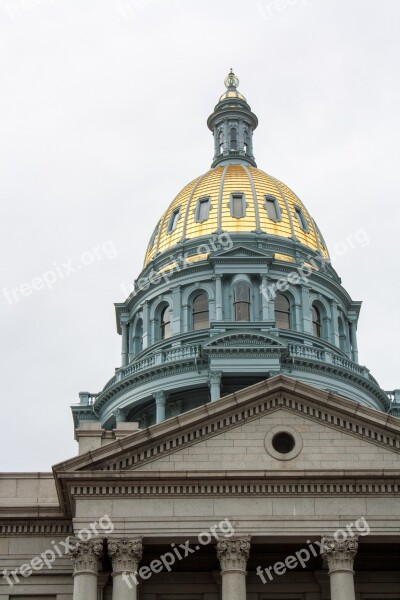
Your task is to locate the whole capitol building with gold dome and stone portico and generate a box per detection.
[0,70,400,600]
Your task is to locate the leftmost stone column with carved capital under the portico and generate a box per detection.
[69,540,103,600]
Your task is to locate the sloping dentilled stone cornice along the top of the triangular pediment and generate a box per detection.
[58,375,400,478]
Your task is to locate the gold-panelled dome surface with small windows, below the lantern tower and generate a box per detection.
[144,164,329,266]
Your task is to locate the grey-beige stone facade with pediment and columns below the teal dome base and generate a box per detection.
[0,376,400,600]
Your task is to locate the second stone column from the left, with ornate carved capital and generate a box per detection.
[108,538,142,600]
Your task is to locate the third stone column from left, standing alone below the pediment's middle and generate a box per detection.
[217,537,250,600]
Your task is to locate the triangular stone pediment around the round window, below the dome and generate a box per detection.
[54,375,400,479]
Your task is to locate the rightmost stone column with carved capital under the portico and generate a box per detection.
[322,537,358,600]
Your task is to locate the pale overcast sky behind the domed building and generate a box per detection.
[0,0,400,471]
